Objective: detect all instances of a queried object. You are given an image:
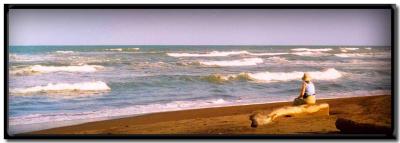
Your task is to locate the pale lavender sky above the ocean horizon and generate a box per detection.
[9,9,391,46]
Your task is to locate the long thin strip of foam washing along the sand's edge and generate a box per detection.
[9,98,230,125]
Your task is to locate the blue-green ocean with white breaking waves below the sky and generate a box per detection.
[8,45,392,134]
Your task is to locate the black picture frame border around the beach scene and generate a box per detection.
[4,4,398,140]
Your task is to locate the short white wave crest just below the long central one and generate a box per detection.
[199,58,264,67]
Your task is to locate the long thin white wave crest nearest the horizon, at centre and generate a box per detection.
[167,51,249,57]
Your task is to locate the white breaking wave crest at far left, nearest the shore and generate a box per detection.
[10,81,111,95]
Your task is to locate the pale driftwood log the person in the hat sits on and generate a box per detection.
[249,103,329,128]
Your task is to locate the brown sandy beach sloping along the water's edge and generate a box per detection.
[21,95,392,134]
